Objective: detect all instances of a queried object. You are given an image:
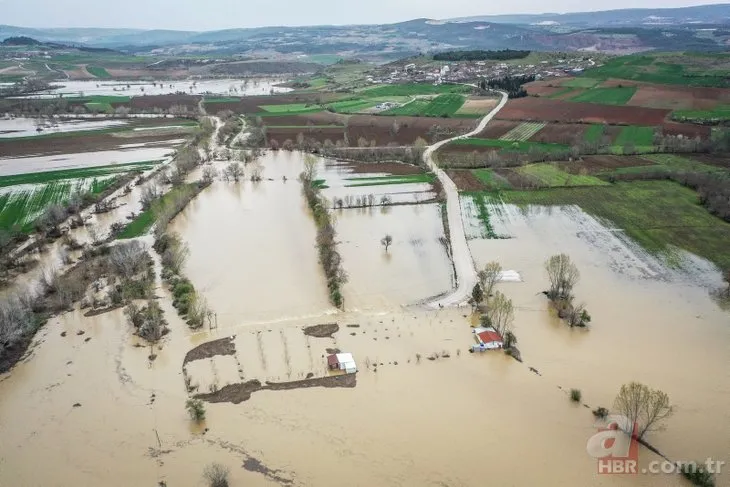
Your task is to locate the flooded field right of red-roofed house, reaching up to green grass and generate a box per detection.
[470,201,730,485]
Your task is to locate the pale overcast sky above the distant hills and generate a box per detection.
[0,0,727,31]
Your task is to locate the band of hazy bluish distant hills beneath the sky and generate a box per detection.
[0,4,730,55]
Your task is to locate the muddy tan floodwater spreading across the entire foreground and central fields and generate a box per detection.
[0,153,730,487]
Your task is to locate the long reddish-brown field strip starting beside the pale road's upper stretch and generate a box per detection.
[498,96,669,125]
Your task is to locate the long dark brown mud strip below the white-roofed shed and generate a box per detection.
[195,374,357,404]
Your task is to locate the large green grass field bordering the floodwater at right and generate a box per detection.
[485,181,730,269]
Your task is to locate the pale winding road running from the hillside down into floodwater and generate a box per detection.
[423,91,507,308]
